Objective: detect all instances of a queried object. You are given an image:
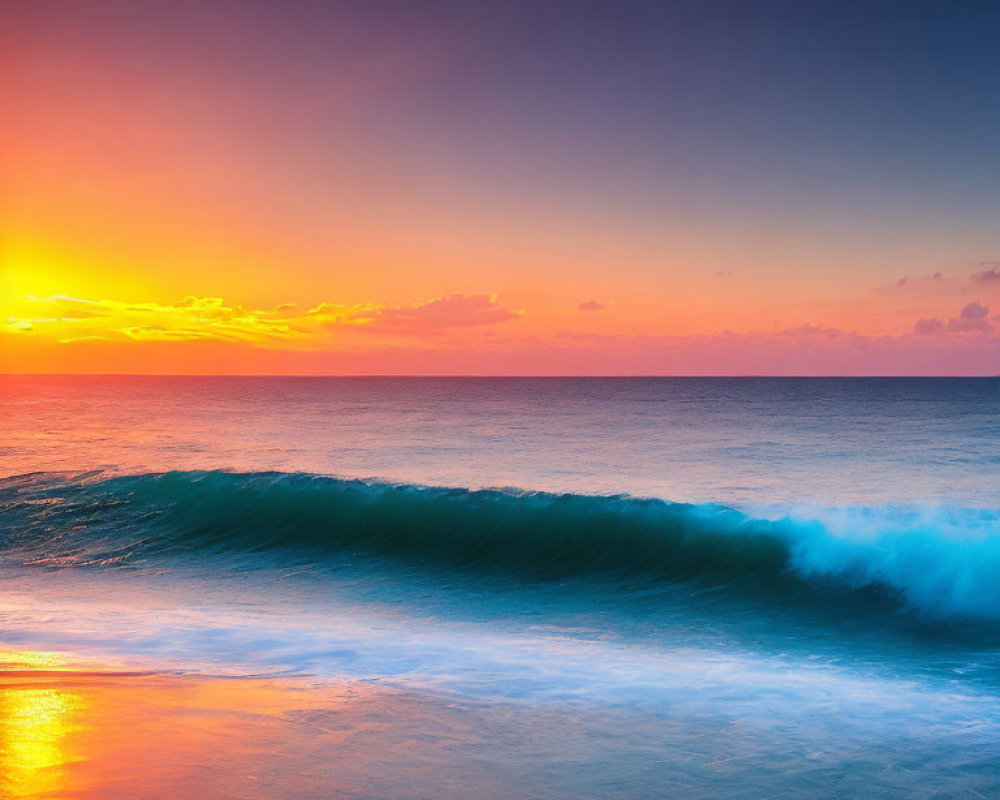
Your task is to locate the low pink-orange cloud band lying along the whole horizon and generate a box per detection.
[11,317,1000,375]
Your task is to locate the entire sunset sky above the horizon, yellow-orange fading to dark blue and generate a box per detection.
[0,0,1000,375]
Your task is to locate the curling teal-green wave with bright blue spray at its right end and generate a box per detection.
[0,471,1000,622]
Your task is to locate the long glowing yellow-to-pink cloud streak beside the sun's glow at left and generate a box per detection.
[2,294,518,348]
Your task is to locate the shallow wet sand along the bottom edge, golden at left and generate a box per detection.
[0,651,1000,800]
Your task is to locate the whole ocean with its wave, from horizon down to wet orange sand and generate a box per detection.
[0,376,1000,798]
